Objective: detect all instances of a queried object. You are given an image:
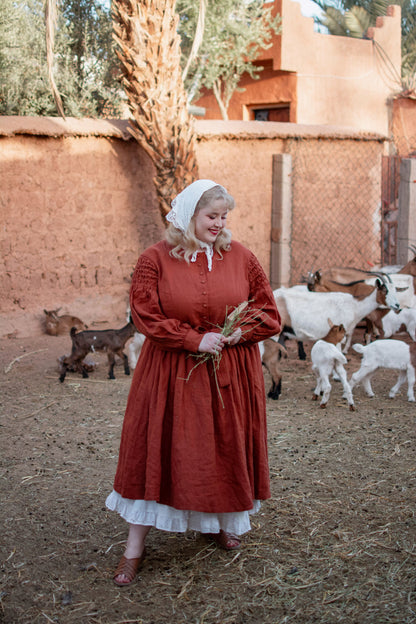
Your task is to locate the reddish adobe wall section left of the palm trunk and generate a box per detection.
[0,117,163,336]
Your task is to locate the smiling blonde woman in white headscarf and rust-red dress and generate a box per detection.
[106,180,280,586]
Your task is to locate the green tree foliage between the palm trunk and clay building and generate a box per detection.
[177,0,280,118]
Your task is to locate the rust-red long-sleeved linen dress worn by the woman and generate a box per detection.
[114,241,280,513]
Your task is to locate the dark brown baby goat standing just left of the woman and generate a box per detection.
[59,321,136,382]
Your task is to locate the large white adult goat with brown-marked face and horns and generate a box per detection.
[274,279,400,353]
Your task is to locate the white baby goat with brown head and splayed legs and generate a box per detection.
[311,319,355,412]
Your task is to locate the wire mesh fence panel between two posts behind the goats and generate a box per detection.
[287,138,382,284]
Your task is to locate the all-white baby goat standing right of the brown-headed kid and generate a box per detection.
[350,339,416,401]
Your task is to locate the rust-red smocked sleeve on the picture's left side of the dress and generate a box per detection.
[130,255,202,352]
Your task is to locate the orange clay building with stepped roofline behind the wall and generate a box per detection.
[195,0,401,135]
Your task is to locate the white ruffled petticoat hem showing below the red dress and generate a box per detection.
[105,490,260,535]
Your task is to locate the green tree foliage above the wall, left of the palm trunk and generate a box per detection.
[0,0,122,117]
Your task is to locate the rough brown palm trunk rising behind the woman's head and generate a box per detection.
[113,0,198,216]
